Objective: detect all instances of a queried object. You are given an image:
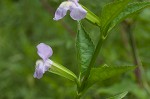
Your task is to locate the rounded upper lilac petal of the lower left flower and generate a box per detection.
[37,43,53,61]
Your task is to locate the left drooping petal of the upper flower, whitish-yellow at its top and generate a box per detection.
[53,1,72,20]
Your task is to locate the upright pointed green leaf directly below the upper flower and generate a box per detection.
[76,22,94,74]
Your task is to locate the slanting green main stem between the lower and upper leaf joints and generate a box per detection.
[79,33,104,93]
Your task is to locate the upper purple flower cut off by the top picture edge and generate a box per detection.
[53,0,87,20]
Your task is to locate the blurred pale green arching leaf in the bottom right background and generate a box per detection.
[97,77,149,99]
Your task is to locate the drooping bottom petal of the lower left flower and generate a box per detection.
[33,60,45,79]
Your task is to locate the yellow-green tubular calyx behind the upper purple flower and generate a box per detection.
[81,5,100,26]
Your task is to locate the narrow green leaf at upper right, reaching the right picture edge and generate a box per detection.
[109,2,150,31]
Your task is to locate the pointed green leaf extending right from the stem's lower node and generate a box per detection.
[87,65,136,87]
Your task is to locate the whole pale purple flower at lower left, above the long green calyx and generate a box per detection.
[33,43,53,79]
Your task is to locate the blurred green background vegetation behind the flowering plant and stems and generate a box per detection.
[0,0,150,99]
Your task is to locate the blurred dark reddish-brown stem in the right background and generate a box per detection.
[122,21,150,94]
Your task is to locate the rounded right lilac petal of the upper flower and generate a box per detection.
[70,5,87,20]
